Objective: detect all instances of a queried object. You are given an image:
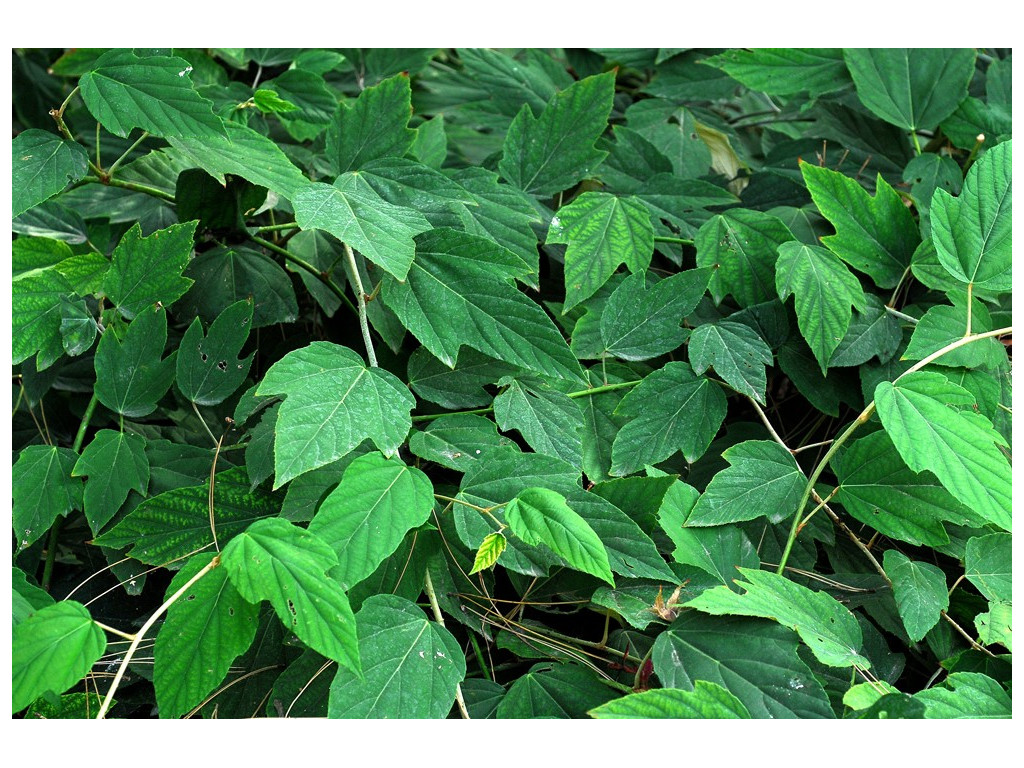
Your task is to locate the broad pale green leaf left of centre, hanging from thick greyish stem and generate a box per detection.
[256,341,416,488]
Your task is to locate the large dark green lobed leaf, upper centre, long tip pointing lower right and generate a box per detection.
[383,228,583,381]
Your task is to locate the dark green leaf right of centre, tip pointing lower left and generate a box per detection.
[610,362,726,475]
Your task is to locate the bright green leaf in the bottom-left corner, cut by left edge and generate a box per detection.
[10,600,106,713]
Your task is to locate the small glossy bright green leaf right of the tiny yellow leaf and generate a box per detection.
[505,487,615,587]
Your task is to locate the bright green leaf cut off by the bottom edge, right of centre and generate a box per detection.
[587,680,751,720]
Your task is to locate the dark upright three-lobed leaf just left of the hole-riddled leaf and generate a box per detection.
[95,309,177,419]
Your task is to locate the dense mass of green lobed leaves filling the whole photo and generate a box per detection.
[12,49,1012,719]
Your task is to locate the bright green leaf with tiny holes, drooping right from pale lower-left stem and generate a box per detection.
[221,517,360,675]
